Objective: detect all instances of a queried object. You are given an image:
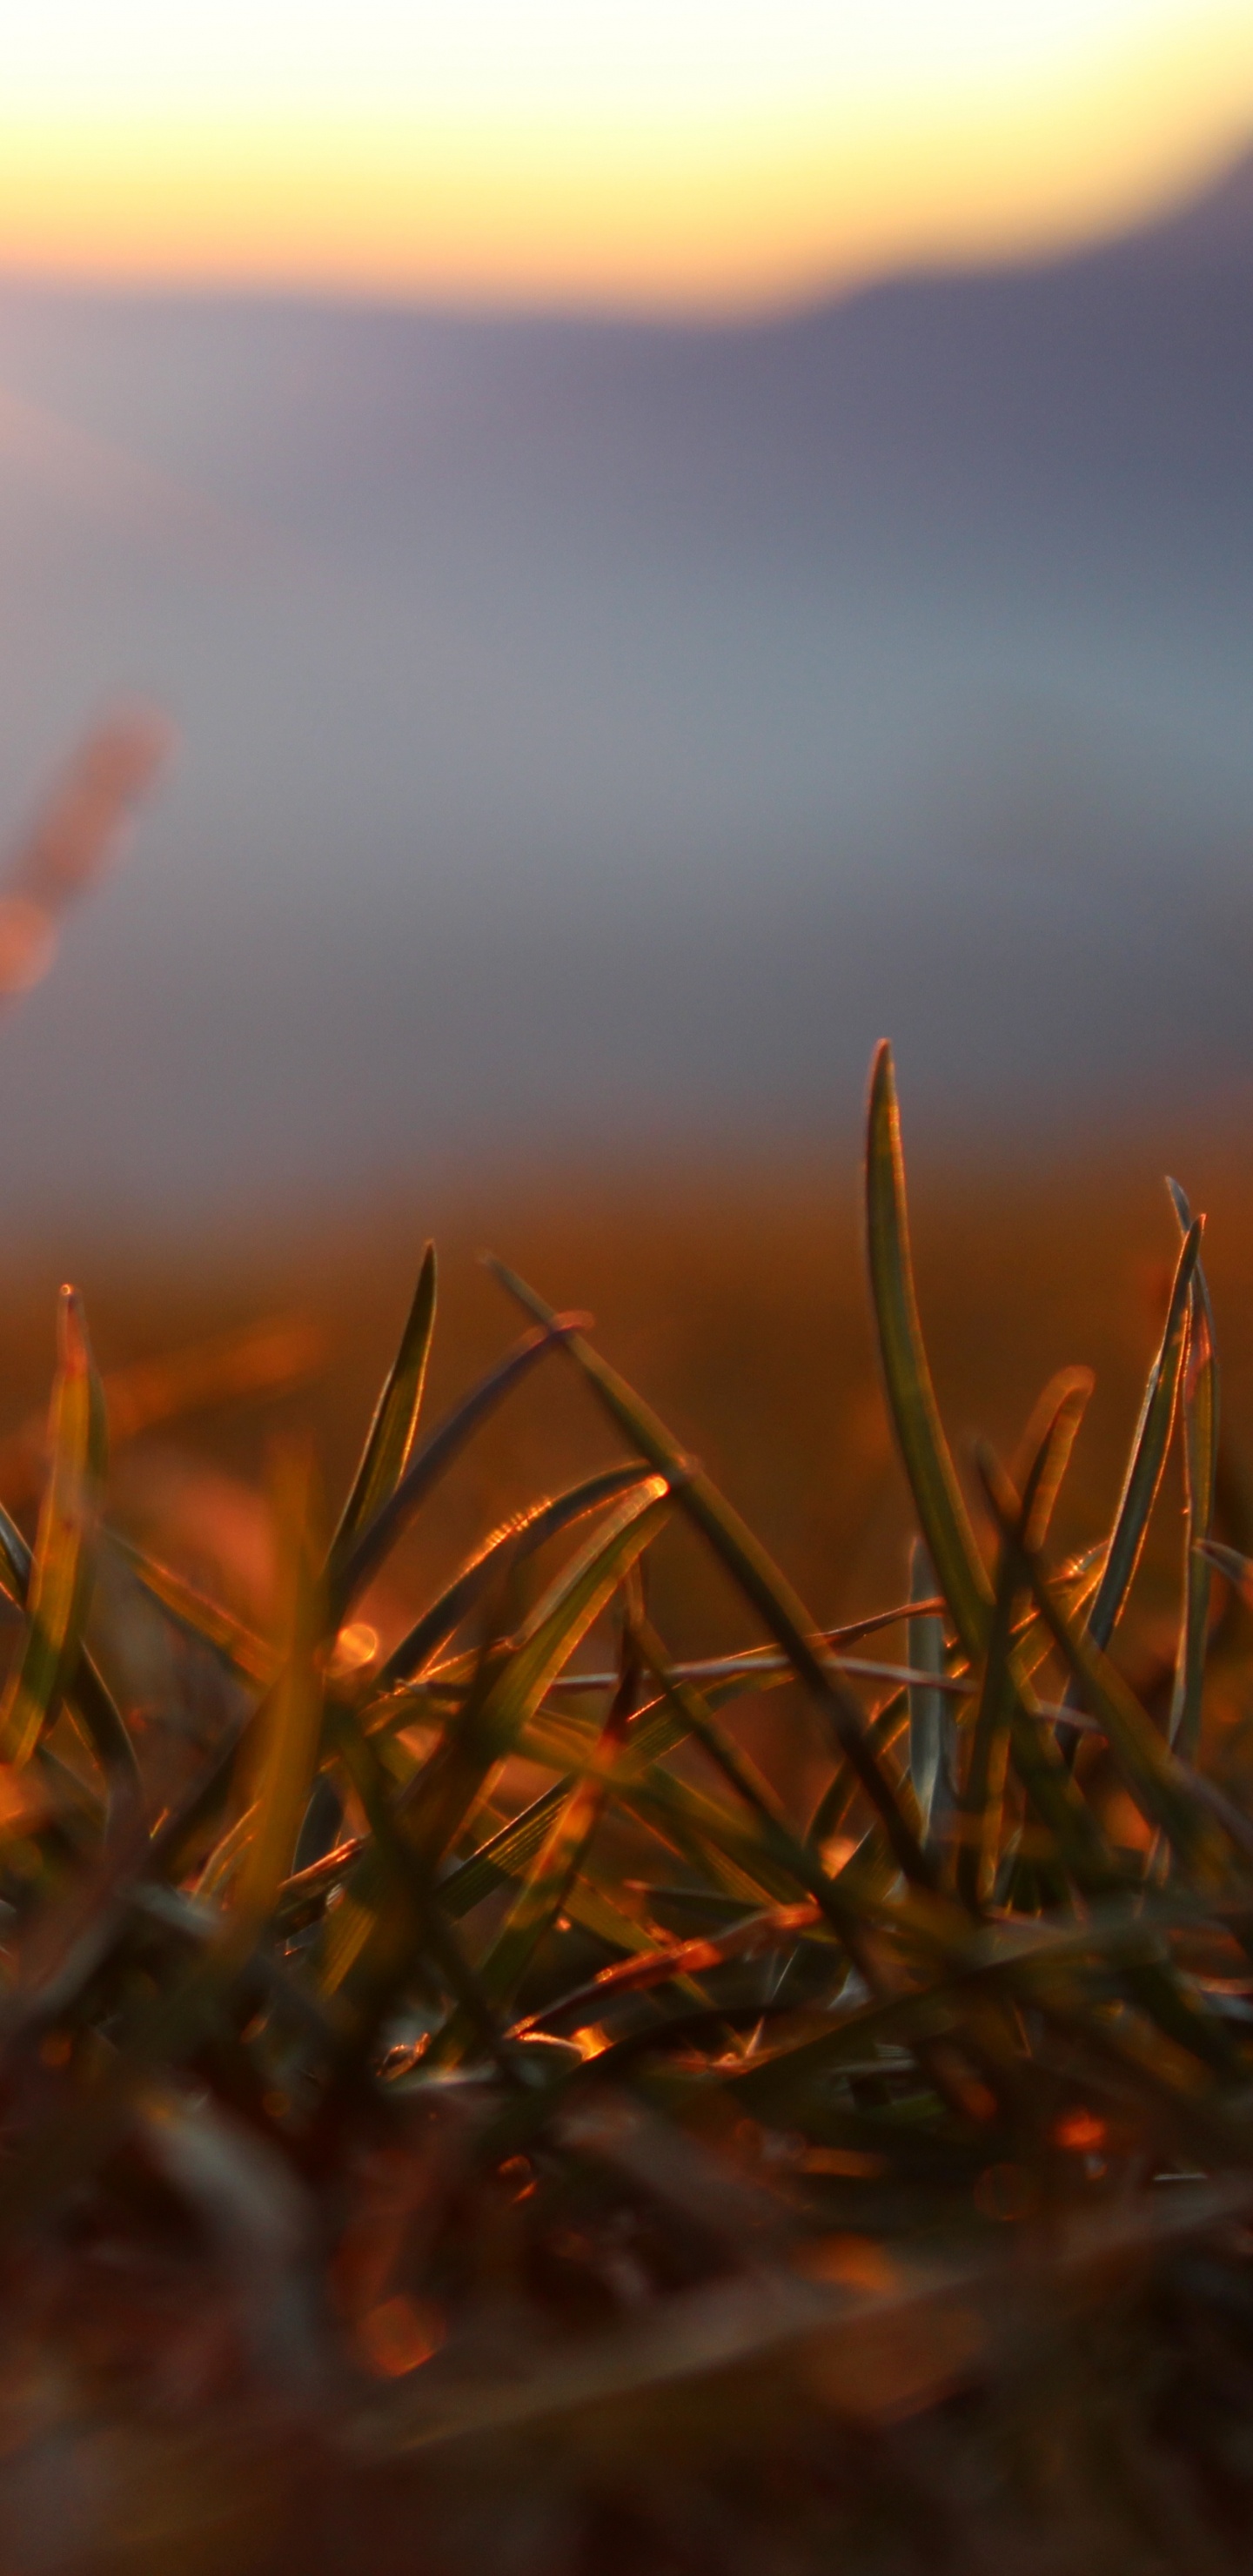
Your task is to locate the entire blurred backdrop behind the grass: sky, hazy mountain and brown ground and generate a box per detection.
[0,0,1253,1636]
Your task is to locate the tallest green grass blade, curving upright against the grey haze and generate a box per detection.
[867,1041,993,1661]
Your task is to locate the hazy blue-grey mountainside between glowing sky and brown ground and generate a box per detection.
[0,133,1253,1229]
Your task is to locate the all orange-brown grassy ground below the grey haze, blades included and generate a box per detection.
[0,1092,1253,2576]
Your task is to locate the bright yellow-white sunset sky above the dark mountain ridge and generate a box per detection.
[0,0,1253,312]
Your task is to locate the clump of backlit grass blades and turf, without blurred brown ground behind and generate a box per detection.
[0,1051,1253,2576]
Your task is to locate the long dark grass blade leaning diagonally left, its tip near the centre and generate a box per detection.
[490,1259,936,1886]
